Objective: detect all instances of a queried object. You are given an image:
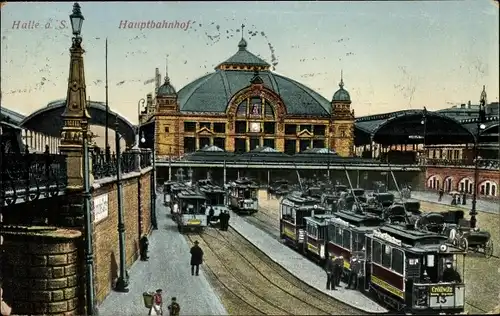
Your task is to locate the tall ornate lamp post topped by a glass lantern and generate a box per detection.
[60,3,97,315]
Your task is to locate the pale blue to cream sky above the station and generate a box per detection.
[1,0,500,123]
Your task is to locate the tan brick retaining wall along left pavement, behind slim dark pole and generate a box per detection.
[92,169,151,304]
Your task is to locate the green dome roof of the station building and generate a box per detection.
[178,40,330,116]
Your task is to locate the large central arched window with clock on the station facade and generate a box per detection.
[234,96,277,152]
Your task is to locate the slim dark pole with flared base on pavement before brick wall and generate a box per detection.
[115,117,129,293]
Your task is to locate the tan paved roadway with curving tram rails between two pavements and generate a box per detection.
[187,228,361,315]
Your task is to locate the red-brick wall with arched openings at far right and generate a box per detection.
[425,166,500,199]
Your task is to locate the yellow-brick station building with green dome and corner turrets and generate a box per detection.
[141,39,354,157]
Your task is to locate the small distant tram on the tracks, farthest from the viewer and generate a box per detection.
[228,178,259,214]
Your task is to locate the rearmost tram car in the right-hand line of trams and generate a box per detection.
[280,191,328,251]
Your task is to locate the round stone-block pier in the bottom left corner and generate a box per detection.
[0,227,85,315]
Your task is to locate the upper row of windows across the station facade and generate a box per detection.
[180,120,326,136]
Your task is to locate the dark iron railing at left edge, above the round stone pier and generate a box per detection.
[0,151,67,207]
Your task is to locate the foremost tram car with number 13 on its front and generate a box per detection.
[364,225,465,315]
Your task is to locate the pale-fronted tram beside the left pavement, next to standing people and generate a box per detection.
[176,188,207,233]
